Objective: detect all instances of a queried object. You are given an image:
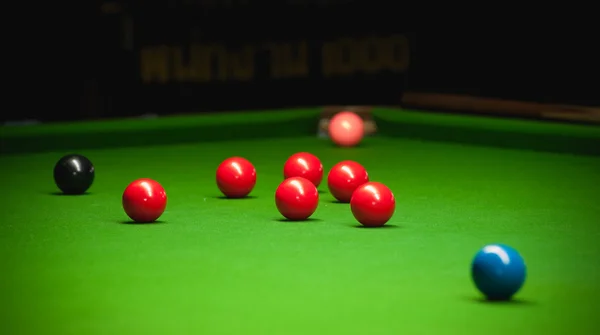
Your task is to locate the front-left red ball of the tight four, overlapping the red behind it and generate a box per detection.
[275,177,319,221]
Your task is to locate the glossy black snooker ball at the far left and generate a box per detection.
[54,154,95,194]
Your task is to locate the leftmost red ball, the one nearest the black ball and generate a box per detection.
[123,178,167,223]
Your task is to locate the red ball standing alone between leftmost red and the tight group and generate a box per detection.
[217,157,256,198]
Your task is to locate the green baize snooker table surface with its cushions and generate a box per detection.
[0,108,600,335]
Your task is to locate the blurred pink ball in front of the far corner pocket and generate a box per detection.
[328,112,365,147]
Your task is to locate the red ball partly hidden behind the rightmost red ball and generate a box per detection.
[327,161,369,203]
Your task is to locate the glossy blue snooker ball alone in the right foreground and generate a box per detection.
[471,244,527,300]
